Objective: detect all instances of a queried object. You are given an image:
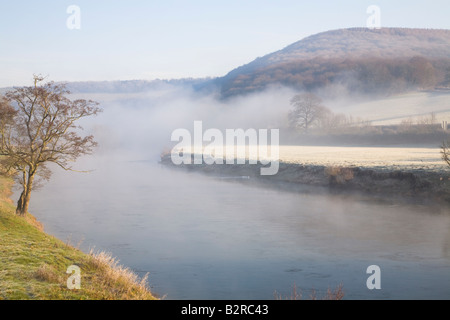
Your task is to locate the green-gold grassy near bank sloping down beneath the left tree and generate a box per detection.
[0,176,155,300]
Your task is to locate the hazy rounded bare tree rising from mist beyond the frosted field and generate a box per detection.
[288,93,330,134]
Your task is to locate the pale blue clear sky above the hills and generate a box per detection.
[0,0,450,87]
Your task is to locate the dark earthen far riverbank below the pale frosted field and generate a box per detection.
[161,154,450,204]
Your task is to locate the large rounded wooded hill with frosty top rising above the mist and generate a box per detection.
[215,28,450,97]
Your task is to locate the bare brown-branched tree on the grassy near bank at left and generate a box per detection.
[0,76,101,216]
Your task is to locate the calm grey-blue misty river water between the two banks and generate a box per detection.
[22,157,450,299]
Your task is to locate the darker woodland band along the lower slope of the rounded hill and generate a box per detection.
[221,56,450,97]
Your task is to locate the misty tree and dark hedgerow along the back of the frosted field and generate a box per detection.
[283,92,450,145]
